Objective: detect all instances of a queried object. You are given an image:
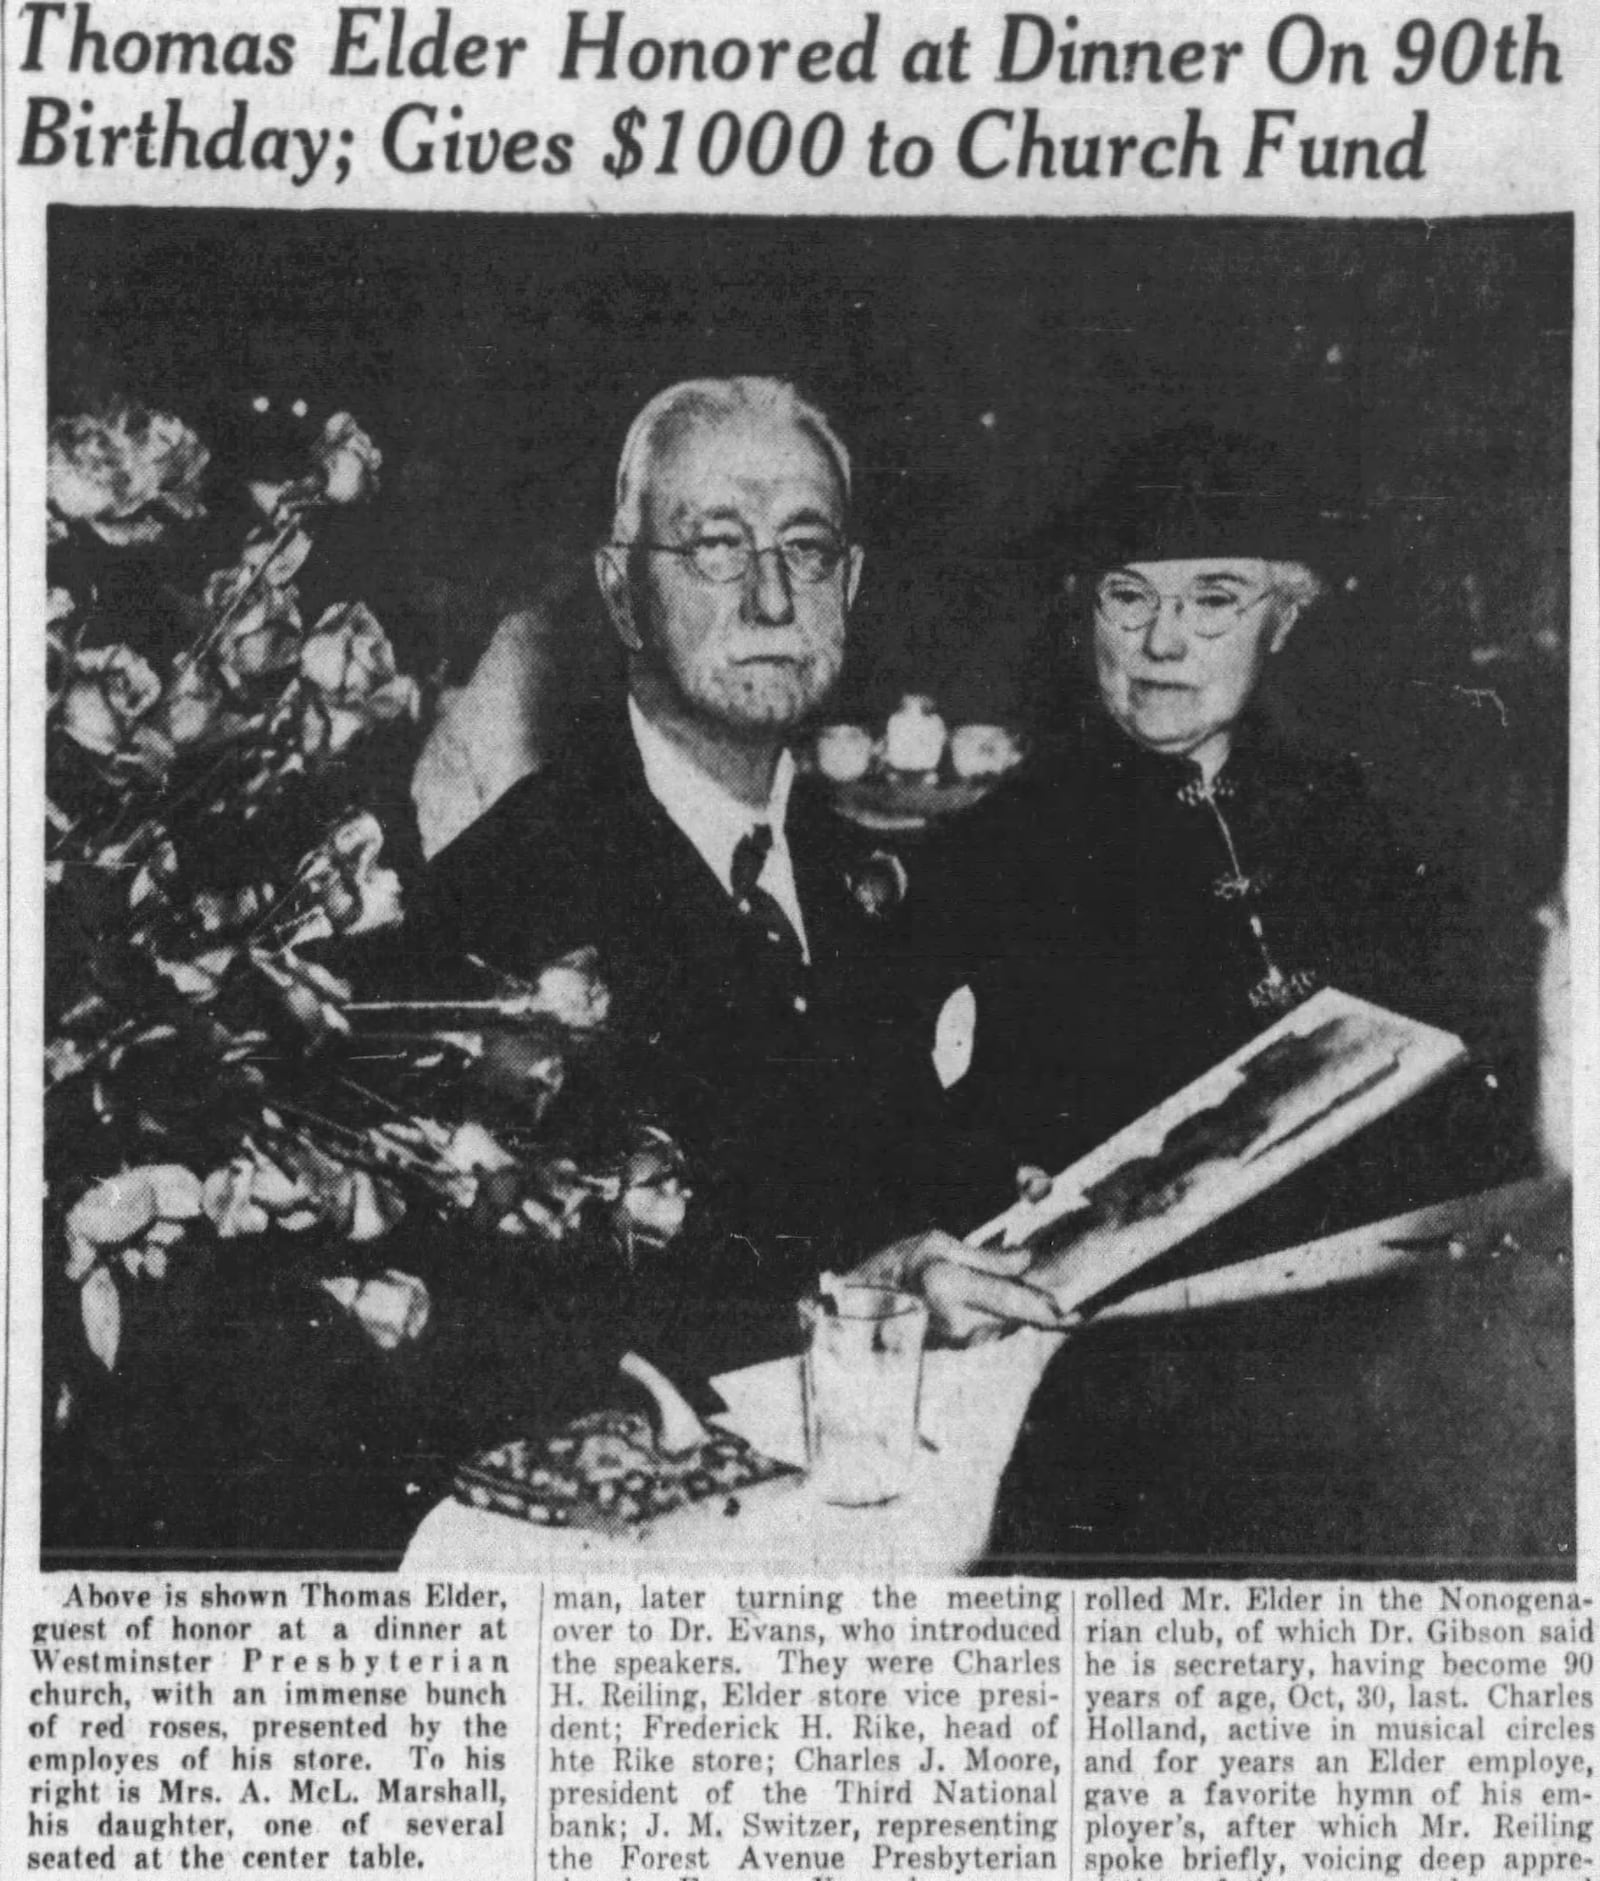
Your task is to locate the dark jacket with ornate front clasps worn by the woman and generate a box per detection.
[914,711,1489,1168]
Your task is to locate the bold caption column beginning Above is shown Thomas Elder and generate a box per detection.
[19,1576,538,1875]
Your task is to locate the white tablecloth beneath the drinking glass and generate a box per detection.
[400,1330,1060,1574]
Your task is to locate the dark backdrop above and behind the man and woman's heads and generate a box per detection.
[49,209,1572,978]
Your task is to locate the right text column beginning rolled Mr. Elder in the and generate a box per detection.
[1074,1580,1594,1877]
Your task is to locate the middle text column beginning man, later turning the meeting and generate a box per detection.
[538,1580,1070,1877]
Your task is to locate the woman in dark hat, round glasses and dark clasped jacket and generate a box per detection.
[948,427,1474,1168]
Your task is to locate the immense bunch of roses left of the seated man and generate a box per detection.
[45,404,686,1403]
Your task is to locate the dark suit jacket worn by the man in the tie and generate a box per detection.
[410,713,962,1414]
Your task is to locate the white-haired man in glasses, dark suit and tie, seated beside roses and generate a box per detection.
[417,378,1051,1414]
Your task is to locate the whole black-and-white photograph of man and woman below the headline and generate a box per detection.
[39,205,1577,1580]
